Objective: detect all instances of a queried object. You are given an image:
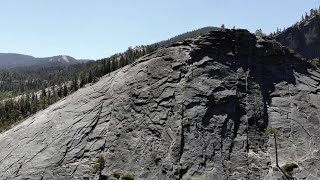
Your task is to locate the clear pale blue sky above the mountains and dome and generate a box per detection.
[0,0,320,59]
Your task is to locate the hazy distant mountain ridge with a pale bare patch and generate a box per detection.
[0,53,85,69]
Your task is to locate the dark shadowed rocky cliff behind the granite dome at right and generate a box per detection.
[276,14,320,59]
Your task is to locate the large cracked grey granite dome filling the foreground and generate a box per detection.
[0,30,320,180]
